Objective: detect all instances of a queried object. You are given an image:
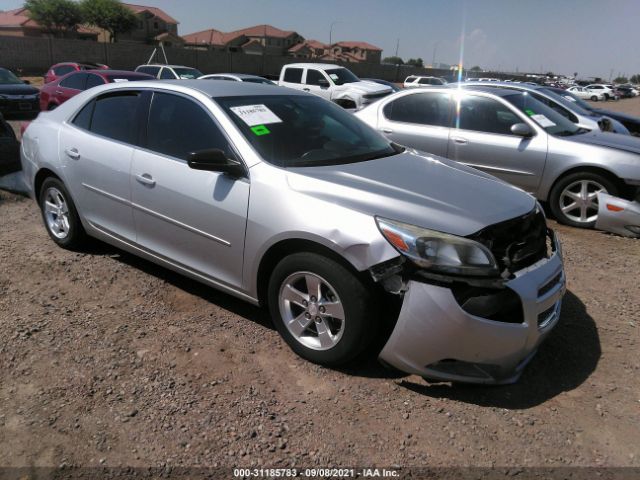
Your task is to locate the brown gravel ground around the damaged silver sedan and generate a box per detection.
[0,187,640,468]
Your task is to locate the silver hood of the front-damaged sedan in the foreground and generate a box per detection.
[287,151,535,235]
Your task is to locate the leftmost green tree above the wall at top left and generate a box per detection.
[24,0,82,37]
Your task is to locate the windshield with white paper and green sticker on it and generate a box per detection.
[220,95,401,168]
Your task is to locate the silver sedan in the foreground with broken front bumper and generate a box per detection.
[22,80,565,383]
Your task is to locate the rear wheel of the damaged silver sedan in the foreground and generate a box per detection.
[39,177,86,250]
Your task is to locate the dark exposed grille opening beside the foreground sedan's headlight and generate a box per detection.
[469,207,548,272]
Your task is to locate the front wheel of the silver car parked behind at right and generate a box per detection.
[549,172,618,228]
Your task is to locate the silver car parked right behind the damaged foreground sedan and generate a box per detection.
[356,86,640,228]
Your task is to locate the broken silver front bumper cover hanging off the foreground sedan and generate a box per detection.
[379,231,566,384]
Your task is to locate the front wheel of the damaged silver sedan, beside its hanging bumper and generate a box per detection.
[268,252,380,367]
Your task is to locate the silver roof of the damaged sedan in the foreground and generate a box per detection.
[86,80,310,98]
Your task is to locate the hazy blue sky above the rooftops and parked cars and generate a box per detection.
[0,0,640,78]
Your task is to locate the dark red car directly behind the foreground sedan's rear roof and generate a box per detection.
[40,70,155,111]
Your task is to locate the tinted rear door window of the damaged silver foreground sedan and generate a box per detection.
[89,91,141,144]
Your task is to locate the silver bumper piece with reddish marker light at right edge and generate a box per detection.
[596,193,640,238]
